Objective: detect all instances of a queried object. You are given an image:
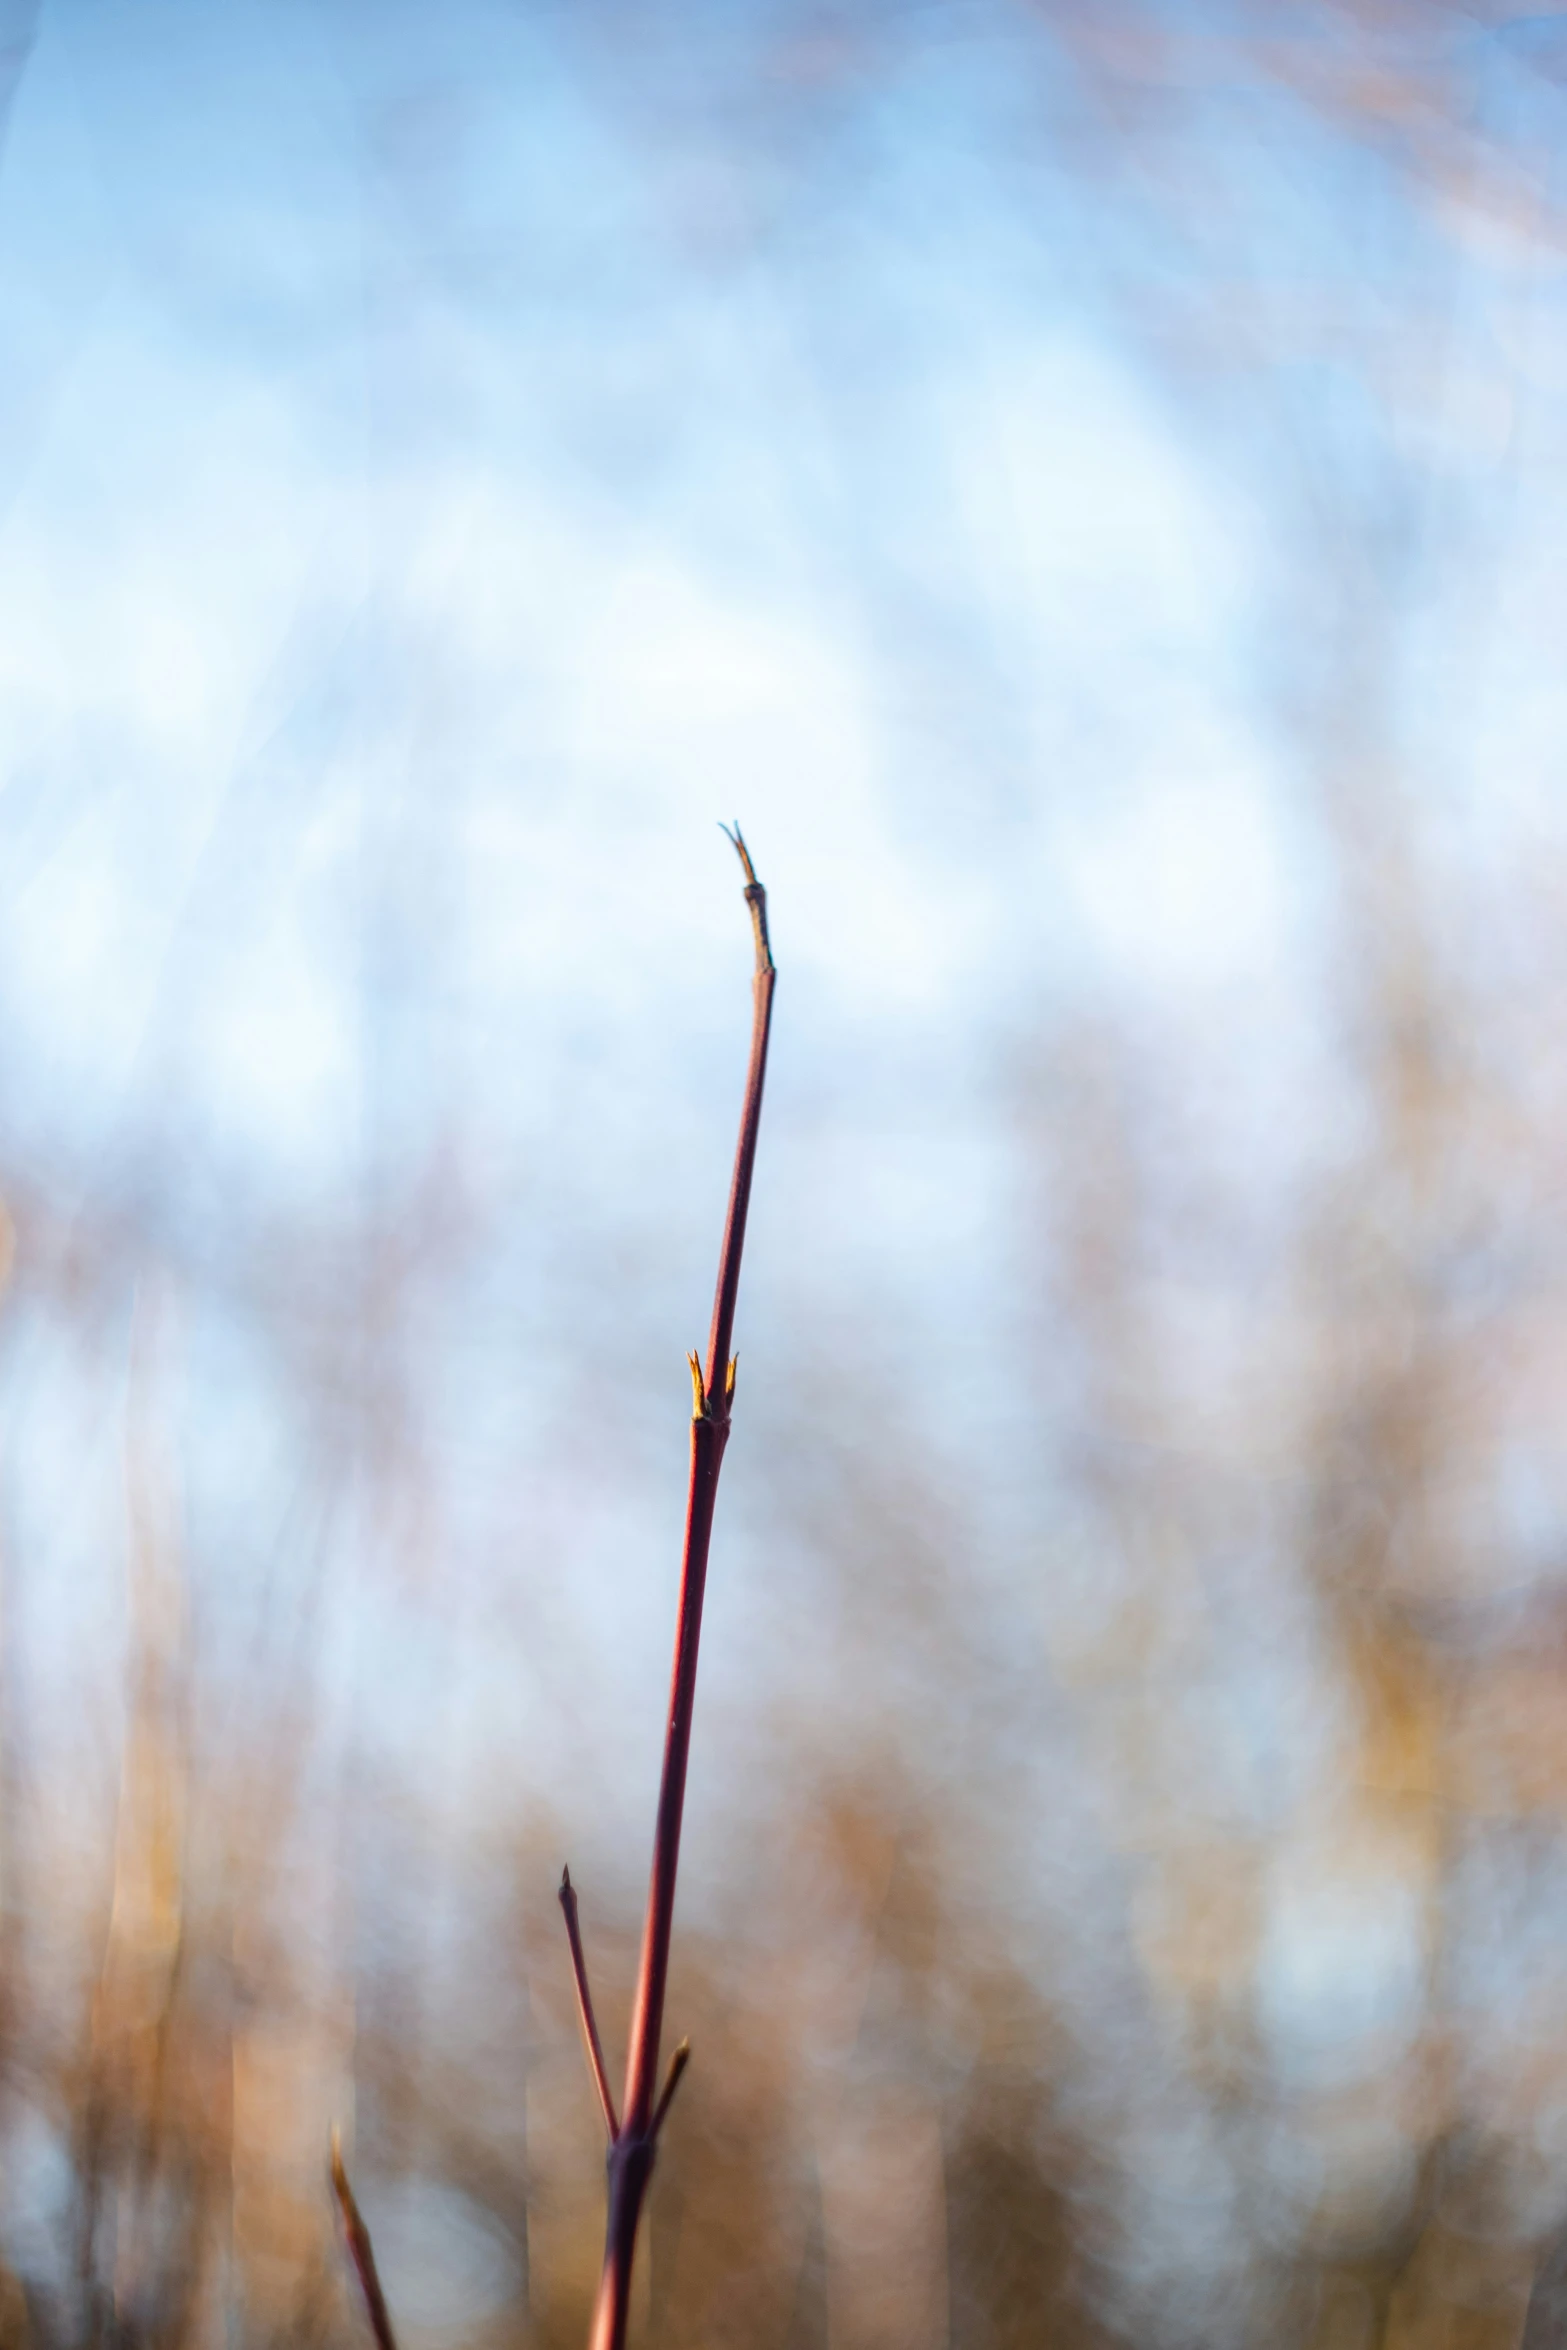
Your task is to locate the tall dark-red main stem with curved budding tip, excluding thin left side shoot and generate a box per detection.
[590,825,778,2350]
